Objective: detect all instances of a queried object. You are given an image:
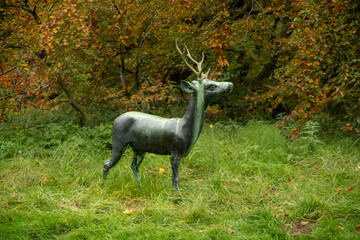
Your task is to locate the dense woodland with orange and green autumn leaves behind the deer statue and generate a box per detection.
[0,0,360,136]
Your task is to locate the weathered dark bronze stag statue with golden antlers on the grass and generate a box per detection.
[103,42,233,191]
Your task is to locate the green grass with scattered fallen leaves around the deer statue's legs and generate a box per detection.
[0,121,360,239]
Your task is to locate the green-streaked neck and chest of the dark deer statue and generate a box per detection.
[180,85,207,156]
